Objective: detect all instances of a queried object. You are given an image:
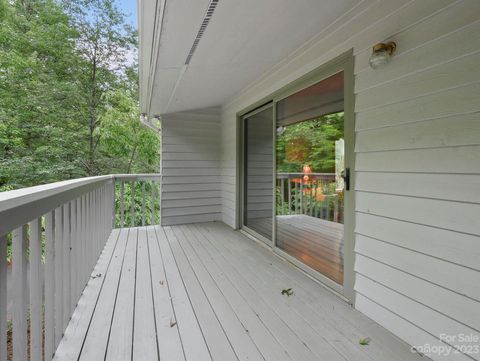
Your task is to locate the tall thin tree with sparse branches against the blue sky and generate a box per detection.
[66,0,136,175]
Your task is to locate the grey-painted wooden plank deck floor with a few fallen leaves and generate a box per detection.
[55,222,420,361]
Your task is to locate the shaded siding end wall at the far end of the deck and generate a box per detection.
[161,108,222,225]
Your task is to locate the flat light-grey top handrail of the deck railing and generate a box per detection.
[0,174,160,236]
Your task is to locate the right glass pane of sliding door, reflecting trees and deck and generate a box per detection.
[276,72,345,285]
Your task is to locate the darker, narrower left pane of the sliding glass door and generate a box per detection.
[243,105,273,241]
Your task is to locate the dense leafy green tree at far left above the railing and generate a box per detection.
[0,0,84,188]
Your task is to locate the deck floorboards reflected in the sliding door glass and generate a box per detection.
[249,214,343,284]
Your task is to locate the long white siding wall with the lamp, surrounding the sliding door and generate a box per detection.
[221,0,480,360]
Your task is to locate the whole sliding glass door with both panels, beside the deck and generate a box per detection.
[241,54,354,300]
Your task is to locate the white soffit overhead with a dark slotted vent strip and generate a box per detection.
[139,0,360,116]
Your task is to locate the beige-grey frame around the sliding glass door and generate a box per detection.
[237,50,355,304]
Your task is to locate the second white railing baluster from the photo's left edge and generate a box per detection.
[12,225,28,361]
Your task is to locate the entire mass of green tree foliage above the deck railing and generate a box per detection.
[0,0,159,190]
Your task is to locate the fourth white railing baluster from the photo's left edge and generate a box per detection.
[45,212,55,360]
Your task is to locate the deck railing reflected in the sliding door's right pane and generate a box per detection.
[276,173,343,223]
